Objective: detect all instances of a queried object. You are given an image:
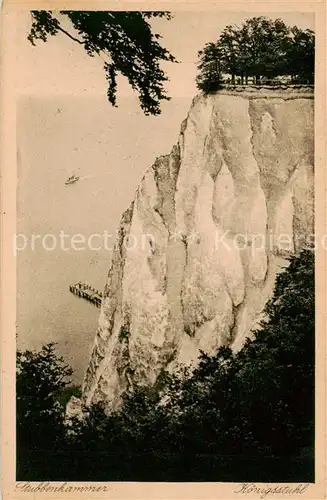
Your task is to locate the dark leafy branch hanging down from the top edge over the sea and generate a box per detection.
[28,10,176,115]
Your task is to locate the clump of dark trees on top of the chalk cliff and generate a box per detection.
[197,17,314,93]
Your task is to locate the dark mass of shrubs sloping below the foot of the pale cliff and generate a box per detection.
[18,250,315,482]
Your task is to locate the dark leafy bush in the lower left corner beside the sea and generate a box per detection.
[16,343,72,472]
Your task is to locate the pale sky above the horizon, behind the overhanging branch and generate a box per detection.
[17,11,314,97]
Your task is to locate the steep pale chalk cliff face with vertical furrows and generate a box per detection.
[83,91,314,407]
